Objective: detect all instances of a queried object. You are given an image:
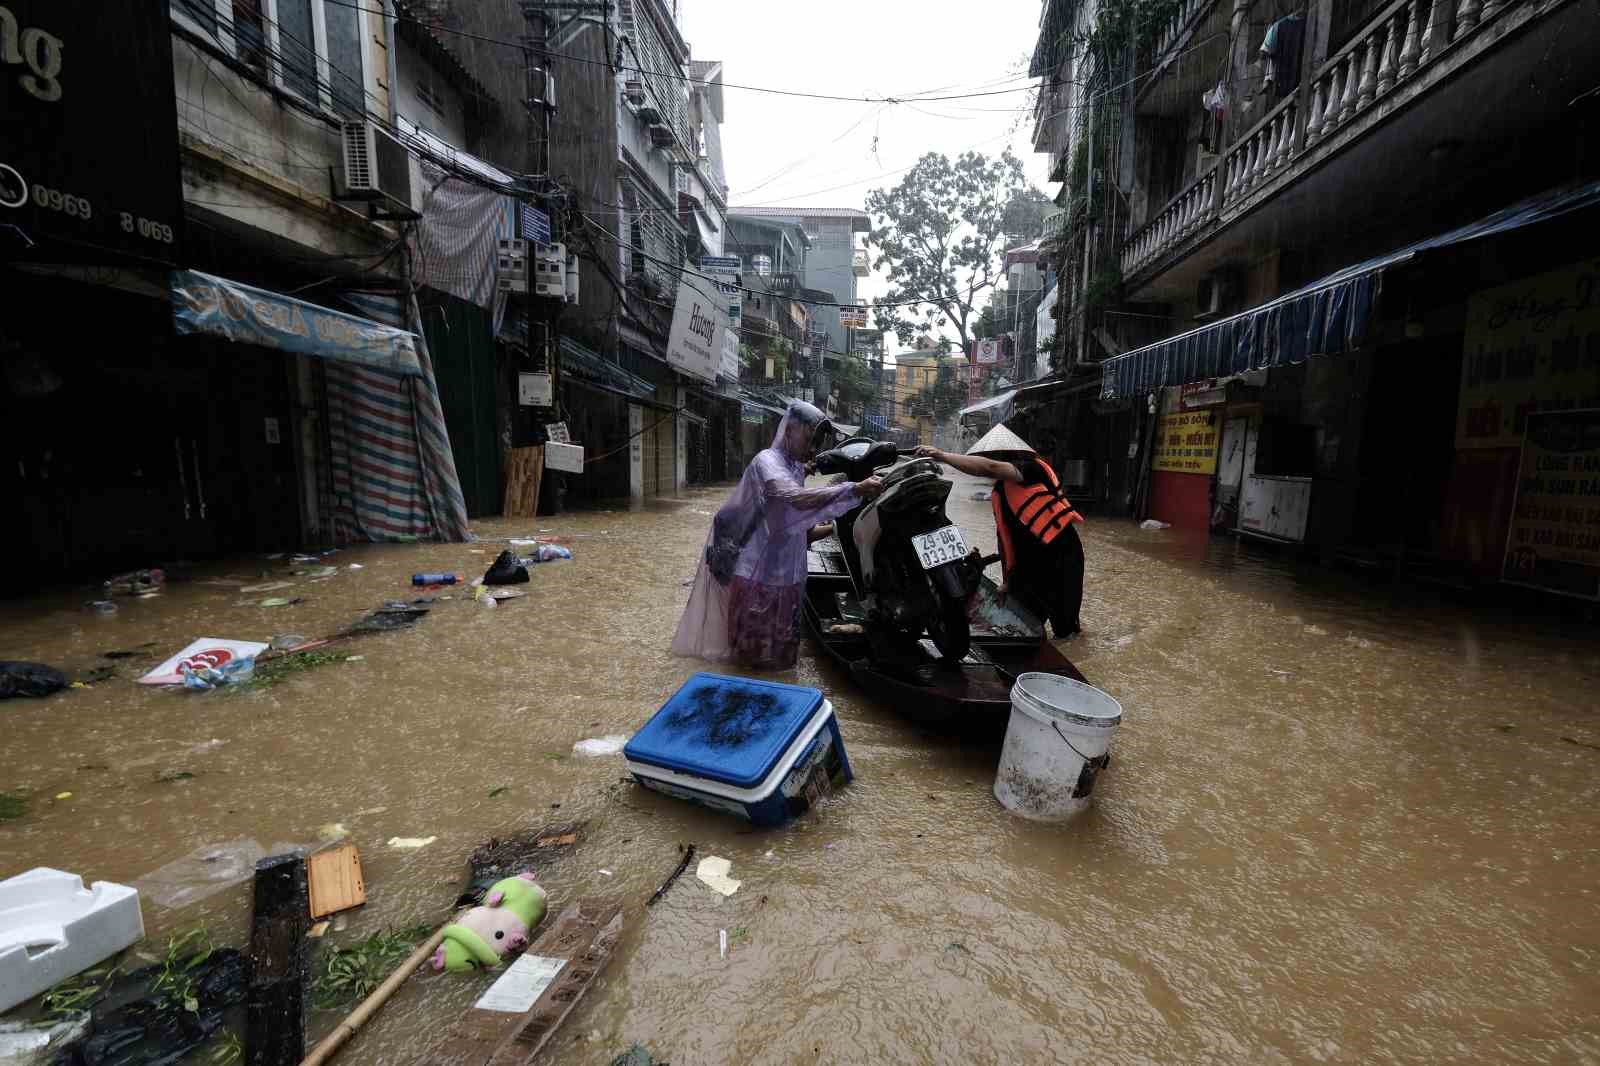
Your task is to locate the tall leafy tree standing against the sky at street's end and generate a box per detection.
[866,149,1048,352]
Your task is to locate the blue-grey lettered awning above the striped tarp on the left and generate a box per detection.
[171,271,422,378]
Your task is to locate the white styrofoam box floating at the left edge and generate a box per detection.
[0,866,144,1013]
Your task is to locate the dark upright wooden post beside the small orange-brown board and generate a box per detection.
[245,855,310,1066]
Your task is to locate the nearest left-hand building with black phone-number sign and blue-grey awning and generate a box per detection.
[0,0,556,578]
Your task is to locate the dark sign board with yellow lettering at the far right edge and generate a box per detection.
[1501,408,1600,600]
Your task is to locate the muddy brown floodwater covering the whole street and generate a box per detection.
[0,477,1600,1066]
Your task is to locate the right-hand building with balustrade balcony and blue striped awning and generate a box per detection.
[1019,0,1600,576]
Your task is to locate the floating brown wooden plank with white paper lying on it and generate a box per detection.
[419,900,622,1066]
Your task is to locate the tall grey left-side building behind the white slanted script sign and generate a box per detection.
[549,0,738,496]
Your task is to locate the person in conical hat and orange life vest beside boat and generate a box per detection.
[917,424,1083,640]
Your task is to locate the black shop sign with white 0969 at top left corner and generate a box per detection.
[0,0,184,264]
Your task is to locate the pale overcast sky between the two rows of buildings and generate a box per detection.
[678,0,1056,349]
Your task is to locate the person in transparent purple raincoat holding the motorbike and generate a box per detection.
[672,402,883,669]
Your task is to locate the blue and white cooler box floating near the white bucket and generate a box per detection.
[622,674,854,826]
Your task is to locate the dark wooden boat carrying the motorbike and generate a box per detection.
[803,543,1088,736]
